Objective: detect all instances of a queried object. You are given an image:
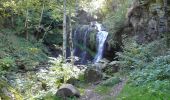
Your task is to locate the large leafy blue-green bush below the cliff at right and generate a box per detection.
[118,39,170,94]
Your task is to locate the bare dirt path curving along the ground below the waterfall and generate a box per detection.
[79,79,127,100]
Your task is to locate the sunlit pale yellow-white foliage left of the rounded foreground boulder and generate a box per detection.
[1,57,83,100]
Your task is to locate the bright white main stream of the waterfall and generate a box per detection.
[94,22,108,63]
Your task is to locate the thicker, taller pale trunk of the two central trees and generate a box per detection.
[63,0,67,61]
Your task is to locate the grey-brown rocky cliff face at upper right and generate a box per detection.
[123,0,170,44]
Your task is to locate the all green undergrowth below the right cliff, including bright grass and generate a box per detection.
[118,39,170,100]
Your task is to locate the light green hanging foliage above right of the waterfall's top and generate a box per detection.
[104,0,133,34]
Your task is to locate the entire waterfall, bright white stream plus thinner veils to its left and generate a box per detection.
[73,22,108,64]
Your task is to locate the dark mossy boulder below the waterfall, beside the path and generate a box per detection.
[84,68,103,83]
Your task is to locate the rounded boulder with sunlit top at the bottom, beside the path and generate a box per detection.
[56,84,80,99]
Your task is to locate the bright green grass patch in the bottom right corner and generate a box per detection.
[117,84,170,100]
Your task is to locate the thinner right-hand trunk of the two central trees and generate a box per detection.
[69,9,74,65]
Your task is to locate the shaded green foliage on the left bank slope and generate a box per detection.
[0,32,48,70]
